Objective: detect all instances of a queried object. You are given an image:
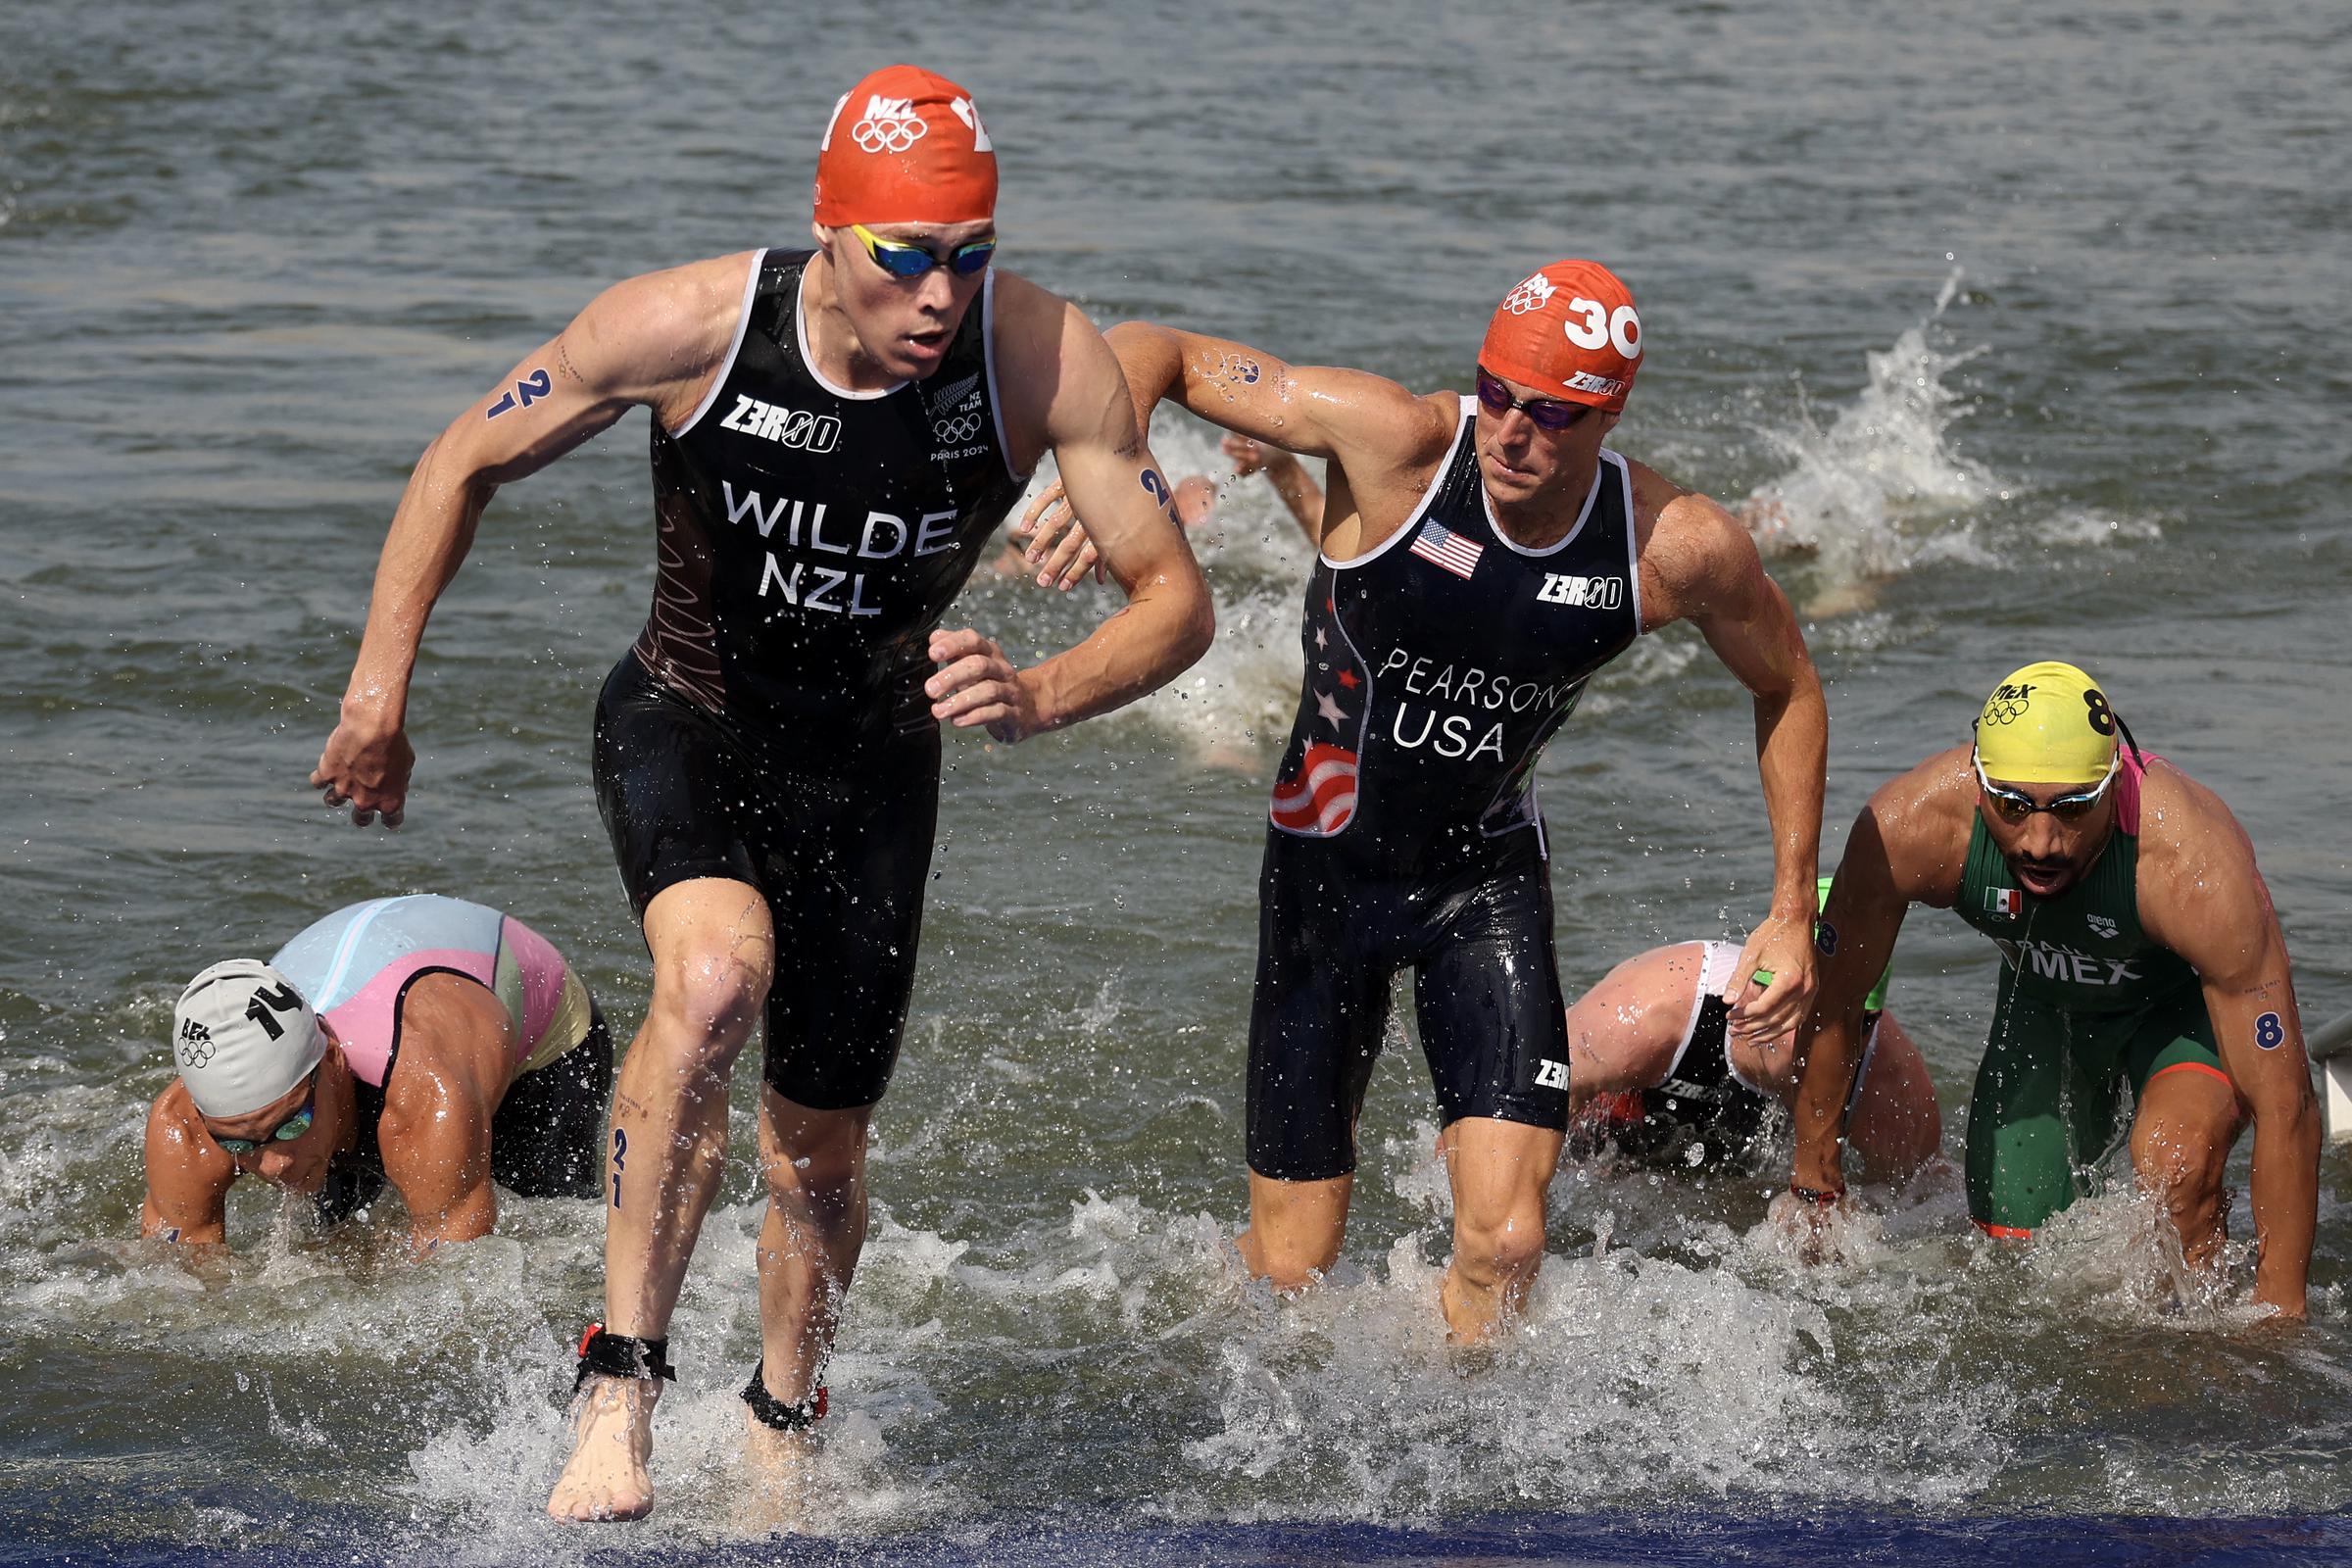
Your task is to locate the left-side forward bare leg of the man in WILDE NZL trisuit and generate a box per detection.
[548,877,776,1519]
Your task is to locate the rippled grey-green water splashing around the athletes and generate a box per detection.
[0,0,2352,1561]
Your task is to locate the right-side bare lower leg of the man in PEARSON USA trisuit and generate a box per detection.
[1440,1116,1562,1343]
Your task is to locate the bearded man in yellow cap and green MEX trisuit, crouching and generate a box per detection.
[1774,661,2319,1319]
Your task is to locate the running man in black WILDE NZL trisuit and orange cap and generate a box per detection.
[313,66,1211,1519]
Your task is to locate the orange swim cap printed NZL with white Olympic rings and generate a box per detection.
[816,66,998,228]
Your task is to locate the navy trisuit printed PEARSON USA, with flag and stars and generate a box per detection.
[1249,411,1642,1183]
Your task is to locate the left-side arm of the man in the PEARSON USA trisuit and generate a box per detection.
[1105,322,1460,555]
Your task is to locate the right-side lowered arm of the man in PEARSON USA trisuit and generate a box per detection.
[1630,464,1830,1039]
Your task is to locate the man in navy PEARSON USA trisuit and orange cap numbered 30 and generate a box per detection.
[1101,261,1828,1340]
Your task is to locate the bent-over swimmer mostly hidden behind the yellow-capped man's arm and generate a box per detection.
[1569,877,1942,1180]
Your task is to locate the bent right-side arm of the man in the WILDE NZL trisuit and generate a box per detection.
[924,275,1216,741]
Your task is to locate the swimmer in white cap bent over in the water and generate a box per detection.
[139,894,612,1250]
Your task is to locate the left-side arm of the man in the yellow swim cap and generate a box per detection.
[1789,748,1976,1192]
